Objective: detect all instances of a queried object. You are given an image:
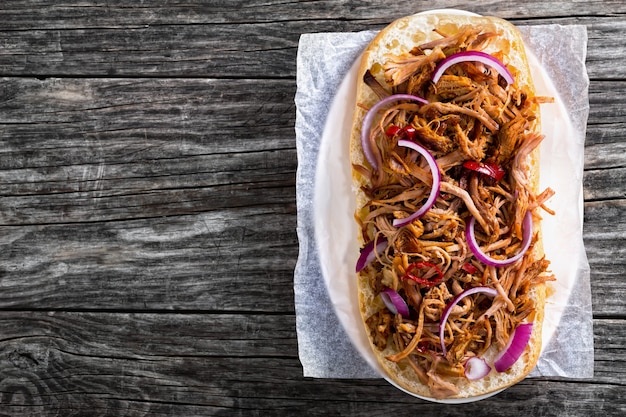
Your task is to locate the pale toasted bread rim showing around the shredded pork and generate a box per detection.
[350,14,546,399]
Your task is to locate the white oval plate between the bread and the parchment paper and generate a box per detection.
[314,9,581,404]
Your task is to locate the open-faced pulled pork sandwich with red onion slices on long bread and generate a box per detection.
[350,14,554,399]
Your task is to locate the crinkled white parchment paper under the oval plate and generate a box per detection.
[294,25,593,378]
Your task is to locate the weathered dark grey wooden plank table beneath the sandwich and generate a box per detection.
[0,0,626,416]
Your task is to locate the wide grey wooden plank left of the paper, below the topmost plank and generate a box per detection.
[0,79,297,225]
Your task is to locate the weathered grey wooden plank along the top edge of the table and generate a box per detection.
[0,0,626,79]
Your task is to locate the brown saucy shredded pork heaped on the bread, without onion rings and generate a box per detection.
[354,22,554,398]
